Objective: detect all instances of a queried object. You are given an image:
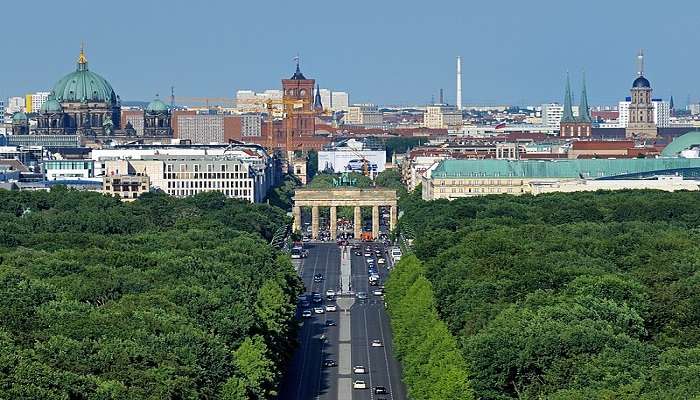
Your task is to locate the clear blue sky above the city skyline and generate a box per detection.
[5,0,700,105]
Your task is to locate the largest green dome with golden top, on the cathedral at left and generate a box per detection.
[53,51,117,104]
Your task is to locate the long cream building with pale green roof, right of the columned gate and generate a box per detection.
[421,158,700,200]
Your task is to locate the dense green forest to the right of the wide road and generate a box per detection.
[387,191,700,400]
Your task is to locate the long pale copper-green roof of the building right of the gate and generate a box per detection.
[431,158,700,179]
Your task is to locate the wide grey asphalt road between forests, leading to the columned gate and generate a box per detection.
[279,242,406,400]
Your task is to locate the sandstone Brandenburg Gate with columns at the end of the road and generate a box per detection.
[292,187,397,240]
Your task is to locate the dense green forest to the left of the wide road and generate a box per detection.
[0,188,302,400]
